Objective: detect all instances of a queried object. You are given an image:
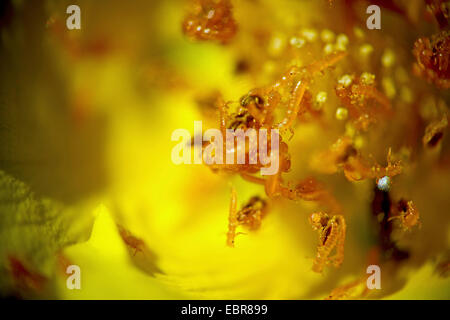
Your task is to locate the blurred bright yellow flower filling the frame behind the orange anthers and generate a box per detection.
[0,0,450,299]
